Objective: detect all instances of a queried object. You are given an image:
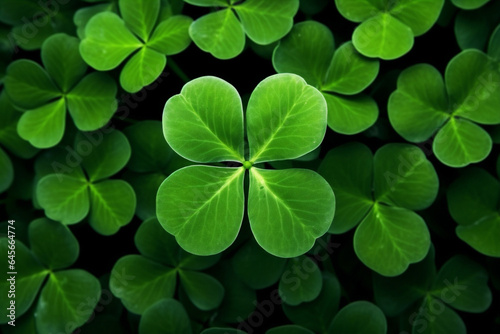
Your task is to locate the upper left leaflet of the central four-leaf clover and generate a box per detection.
[163,76,244,162]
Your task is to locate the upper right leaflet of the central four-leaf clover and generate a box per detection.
[246,73,327,163]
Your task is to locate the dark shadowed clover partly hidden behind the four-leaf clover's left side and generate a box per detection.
[123,121,191,220]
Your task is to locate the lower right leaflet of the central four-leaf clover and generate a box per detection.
[248,167,335,257]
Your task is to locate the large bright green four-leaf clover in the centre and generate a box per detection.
[157,74,335,257]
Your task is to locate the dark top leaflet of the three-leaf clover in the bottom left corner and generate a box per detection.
[29,218,80,269]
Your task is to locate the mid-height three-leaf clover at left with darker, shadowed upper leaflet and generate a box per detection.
[36,130,136,235]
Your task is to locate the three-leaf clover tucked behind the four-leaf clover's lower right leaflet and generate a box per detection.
[319,143,439,276]
